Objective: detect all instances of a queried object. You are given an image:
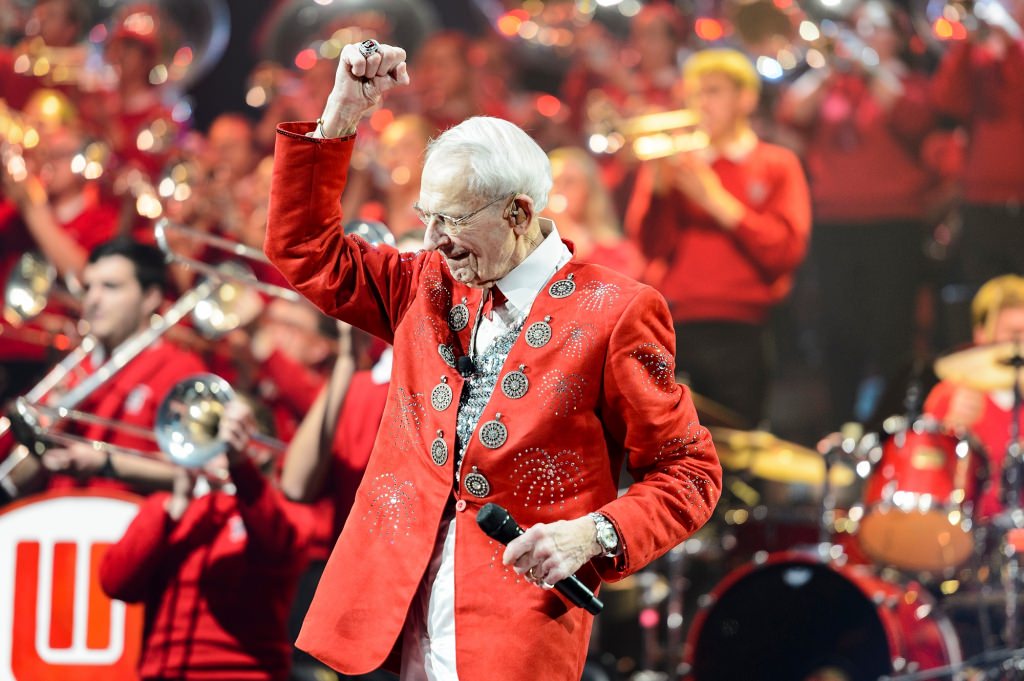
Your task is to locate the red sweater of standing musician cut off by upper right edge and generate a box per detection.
[932,42,1024,204]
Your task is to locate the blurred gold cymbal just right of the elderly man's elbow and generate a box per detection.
[710,428,856,487]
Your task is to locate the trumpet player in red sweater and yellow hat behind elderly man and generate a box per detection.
[627,49,810,427]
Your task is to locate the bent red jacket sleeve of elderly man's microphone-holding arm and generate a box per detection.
[595,287,722,580]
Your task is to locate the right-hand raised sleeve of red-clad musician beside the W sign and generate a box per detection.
[229,457,309,560]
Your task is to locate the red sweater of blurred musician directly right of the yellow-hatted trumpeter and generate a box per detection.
[786,74,932,223]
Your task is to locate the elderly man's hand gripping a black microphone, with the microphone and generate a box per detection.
[476,504,604,614]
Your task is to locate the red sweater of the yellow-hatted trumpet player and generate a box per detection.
[627,142,811,324]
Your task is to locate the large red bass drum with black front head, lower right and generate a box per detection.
[684,552,962,681]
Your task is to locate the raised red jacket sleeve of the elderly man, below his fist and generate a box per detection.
[263,123,429,343]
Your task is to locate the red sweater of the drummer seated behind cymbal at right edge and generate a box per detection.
[925,381,1024,518]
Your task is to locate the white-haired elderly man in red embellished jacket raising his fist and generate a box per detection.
[265,41,721,681]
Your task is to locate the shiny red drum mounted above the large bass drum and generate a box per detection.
[857,419,984,571]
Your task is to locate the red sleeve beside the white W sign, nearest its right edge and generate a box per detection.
[99,494,174,603]
